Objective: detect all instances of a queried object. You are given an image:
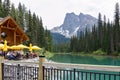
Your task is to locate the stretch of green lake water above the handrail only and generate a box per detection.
[50,54,120,66]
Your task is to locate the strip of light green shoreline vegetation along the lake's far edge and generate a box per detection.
[37,49,120,59]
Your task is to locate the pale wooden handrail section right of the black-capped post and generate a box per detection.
[43,62,120,72]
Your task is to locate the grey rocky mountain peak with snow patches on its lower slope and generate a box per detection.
[51,13,97,38]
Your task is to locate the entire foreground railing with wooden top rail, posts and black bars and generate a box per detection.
[0,57,120,80]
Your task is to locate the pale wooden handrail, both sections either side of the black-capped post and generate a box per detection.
[3,60,120,72]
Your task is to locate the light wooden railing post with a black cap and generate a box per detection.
[38,56,45,80]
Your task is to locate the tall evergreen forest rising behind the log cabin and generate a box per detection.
[0,0,52,51]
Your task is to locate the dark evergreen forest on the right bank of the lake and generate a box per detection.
[70,3,120,55]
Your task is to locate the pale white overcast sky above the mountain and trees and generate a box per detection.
[11,0,120,29]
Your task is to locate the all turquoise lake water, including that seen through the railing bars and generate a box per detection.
[50,54,120,80]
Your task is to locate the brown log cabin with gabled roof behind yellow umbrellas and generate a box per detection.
[0,16,29,46]
